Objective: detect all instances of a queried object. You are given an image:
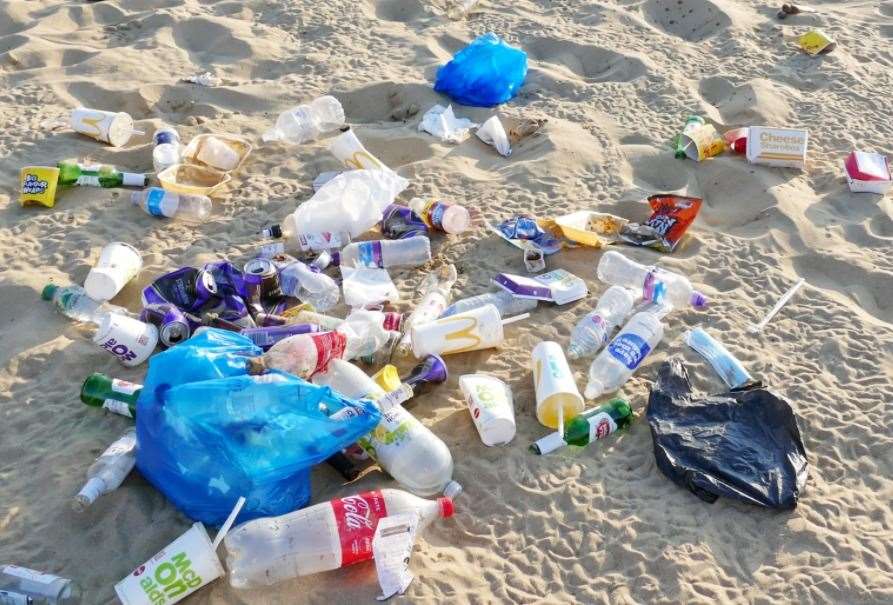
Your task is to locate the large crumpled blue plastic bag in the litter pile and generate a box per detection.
[136,329,381,525]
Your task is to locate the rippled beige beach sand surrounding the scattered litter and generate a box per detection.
[0,0,893,605]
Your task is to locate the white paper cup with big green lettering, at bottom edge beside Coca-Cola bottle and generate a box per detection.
[115,523,224,605]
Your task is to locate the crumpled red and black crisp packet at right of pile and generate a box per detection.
[620,194,702,252]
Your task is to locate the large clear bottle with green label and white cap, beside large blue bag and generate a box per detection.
[314,360,462,497]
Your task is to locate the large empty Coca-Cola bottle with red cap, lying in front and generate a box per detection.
[224,489,453,588]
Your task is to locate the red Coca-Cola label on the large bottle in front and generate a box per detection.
[331,490,388,567]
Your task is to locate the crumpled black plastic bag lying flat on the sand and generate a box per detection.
[647,358,808,509]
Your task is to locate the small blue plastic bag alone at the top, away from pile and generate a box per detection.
[434,33,527,107]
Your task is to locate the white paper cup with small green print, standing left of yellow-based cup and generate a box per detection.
[459,374,515,446]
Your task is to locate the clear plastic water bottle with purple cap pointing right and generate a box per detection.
[597,250,707,309]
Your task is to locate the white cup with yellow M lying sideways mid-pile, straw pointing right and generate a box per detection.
[412,305,505,359]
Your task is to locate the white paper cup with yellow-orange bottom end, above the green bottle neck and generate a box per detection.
[531,341,584,429]
